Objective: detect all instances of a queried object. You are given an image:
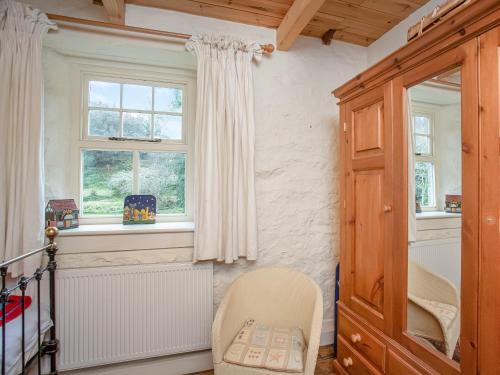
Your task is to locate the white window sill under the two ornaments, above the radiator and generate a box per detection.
[59,222,194,237]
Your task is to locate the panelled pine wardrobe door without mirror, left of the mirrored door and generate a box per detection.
[341,83,393,332]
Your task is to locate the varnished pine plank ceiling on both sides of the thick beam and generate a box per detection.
[124,0,429,49]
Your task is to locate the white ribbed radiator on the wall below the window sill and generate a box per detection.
[56,263,213,370]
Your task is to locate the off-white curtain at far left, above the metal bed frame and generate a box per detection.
[0,0,55,276]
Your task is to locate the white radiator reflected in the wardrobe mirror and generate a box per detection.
[408,238,462,293]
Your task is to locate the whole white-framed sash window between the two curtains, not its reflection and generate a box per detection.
[80,77,192,222]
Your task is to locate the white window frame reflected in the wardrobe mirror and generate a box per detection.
[412,105,439,211]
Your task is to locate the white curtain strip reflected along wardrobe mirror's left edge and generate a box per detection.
[406,90,417,242]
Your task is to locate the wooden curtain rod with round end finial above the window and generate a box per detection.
[47,13,274,53]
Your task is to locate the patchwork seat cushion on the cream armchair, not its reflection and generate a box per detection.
[224,319,307,372]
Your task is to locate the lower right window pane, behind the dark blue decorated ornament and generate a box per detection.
[139,152,186,214]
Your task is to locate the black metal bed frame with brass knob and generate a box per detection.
[0,227,59,375]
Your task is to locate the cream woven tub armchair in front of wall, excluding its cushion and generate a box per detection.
[212,268,323,375]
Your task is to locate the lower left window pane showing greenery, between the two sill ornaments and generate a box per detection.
[82,150,133,215]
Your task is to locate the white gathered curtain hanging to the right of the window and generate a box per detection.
[186,35,261,263]
